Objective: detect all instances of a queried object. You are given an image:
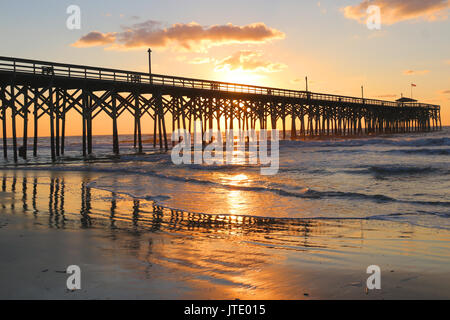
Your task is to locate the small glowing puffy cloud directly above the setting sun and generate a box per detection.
[215,50,287,72]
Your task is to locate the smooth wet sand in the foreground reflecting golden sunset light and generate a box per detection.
[0,170,450,299]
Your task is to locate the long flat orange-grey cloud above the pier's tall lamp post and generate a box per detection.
[73,20,285,51]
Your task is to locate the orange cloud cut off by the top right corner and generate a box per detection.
[341,0,450,25]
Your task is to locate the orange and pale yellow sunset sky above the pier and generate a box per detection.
[0,0,450,135]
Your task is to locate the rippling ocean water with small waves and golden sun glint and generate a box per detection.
[0,127,450,229]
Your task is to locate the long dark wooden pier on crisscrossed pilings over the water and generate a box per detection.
[0,57,442,161]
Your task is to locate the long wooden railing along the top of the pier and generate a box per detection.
[0,57,439,109]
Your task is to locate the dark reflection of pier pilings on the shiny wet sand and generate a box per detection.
[1,170,320,236]
